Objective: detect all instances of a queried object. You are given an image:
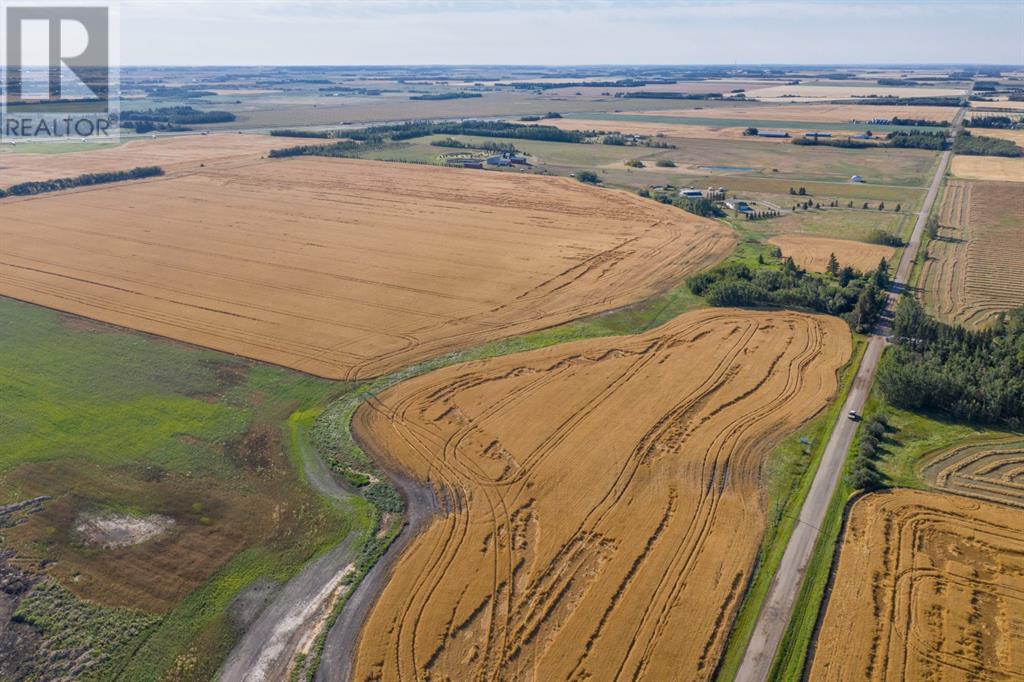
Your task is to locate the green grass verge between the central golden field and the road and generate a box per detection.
[715,335,867,680]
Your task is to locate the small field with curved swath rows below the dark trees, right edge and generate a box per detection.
[921,438,1024,508]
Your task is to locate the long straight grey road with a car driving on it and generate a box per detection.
[736,109,965,682]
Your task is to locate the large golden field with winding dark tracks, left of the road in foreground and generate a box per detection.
[352,309,851,680]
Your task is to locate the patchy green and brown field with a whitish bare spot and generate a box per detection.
[0,296,364,680]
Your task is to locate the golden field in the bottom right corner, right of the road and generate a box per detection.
[809,489,1024,681]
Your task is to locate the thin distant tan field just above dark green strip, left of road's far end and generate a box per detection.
[637,103,956,125]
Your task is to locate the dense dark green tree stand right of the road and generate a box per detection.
[879,296,1024,429]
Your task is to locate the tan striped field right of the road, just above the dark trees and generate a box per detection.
[921,180,1024,327]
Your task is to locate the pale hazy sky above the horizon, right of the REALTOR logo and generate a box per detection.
[121,0,1024,65]
